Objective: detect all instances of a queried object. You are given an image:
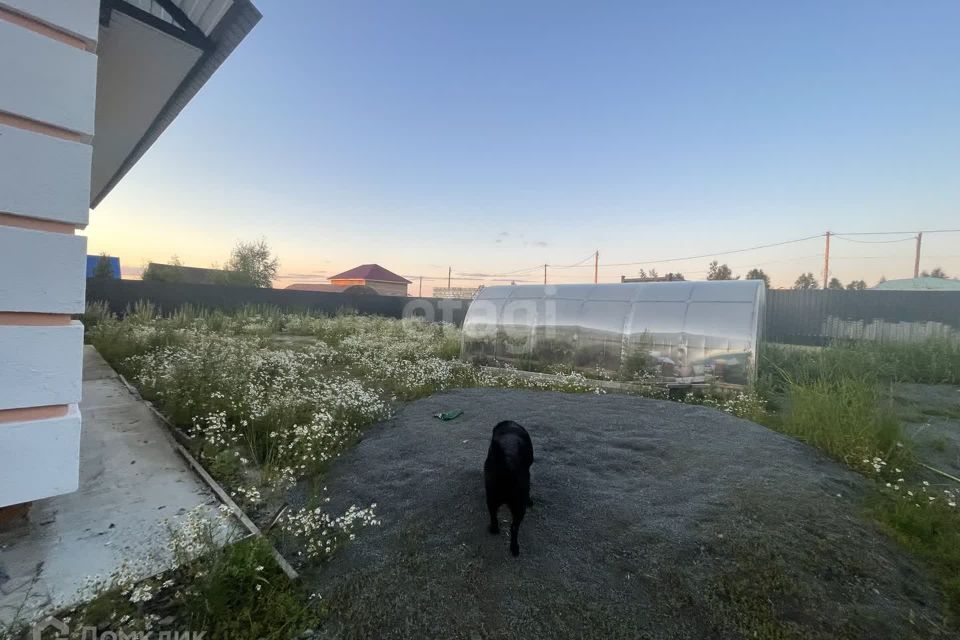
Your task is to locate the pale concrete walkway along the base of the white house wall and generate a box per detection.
[0,346,225,628]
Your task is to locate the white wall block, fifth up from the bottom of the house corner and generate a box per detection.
[0,19,97,135]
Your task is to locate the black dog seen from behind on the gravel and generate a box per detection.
[483,420,533,556]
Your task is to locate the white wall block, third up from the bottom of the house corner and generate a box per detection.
[0,226,87,314]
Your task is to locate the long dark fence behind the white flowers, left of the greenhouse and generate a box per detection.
[87,278,470,326]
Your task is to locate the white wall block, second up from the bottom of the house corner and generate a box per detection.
[0,321,83,408]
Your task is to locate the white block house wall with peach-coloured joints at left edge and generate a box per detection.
[0,0,99,509]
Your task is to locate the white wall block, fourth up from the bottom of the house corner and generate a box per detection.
[0,125,93,226]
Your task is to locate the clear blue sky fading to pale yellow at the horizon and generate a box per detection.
[86,0,960,294]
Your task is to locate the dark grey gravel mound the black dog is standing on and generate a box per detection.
[296,389,954,640]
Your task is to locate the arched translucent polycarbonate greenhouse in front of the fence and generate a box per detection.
[461,280,765,386]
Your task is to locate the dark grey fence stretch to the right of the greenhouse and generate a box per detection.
[764,290,960,345]
